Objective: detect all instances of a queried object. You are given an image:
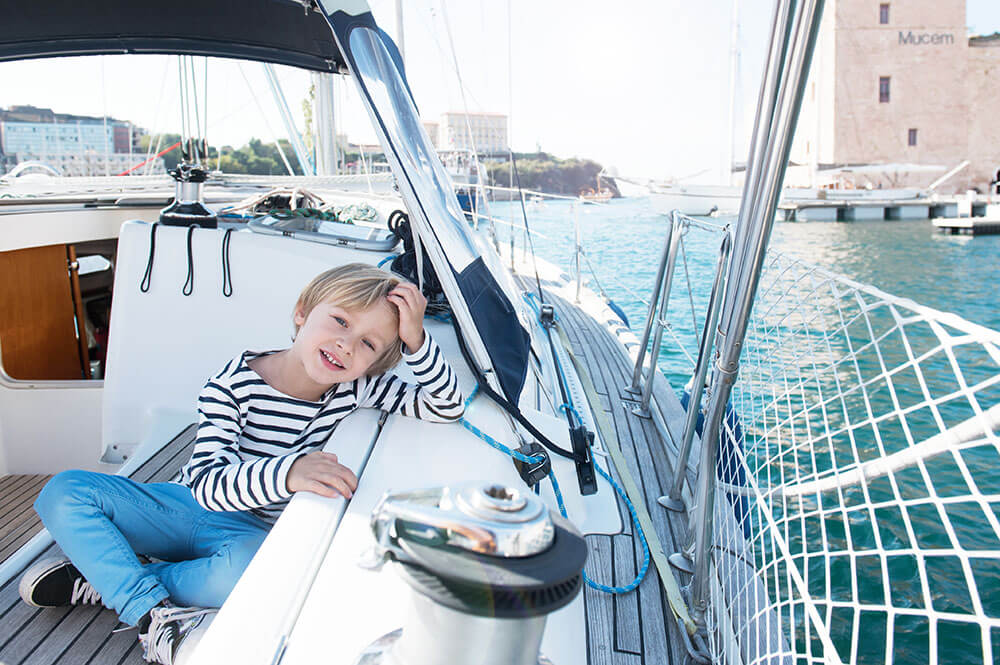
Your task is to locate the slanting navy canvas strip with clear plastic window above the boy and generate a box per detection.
[323,3,530,404]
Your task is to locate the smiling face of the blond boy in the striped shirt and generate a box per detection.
[292,301,399,388]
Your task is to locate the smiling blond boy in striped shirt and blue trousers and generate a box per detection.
[20,263,463,665]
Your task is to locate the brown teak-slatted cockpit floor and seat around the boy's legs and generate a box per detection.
[0,425,195,665]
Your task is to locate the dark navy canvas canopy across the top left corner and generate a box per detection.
[0,0,344,72]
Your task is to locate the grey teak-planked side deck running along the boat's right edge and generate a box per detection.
[543,280,687,665]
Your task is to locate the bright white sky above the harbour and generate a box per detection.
[0,0,1000,182]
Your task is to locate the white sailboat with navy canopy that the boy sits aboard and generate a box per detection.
[0,0,1000,665]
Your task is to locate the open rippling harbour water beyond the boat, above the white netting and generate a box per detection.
[491,198,1000,375]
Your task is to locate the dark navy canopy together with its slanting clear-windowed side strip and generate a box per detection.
[0,0,530,404]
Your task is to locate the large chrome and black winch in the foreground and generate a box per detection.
[356,484,587,665]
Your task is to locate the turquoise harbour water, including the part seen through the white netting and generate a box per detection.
[492,199,1000,663]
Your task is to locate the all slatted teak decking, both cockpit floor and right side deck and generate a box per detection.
[0,294,686,665]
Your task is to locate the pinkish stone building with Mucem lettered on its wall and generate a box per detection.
[786,0,1000,192]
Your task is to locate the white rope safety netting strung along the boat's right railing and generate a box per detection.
[708,252,1000,665]
